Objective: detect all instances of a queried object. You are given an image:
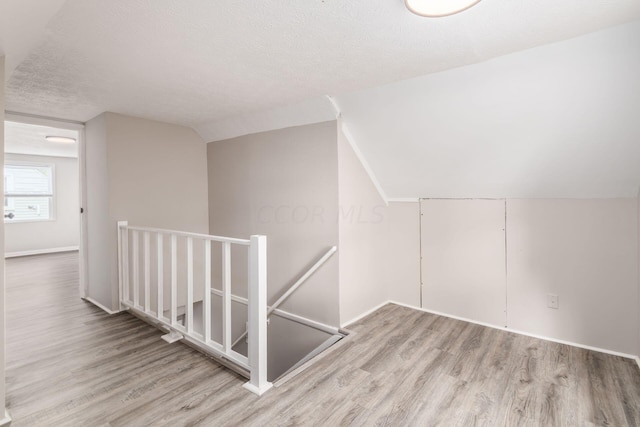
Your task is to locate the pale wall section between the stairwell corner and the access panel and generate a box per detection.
[338,126,420,325]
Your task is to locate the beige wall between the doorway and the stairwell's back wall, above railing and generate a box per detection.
[86,113,209,309]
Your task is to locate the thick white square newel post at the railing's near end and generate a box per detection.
[244,236,272,396]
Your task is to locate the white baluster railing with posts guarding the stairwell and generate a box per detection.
[118,221,272,395]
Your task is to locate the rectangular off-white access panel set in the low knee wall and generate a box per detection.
[420,199,506,327]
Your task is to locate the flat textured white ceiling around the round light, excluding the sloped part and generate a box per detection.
[1,0,640,130]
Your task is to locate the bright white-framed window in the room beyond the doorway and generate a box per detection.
[4,163,53,222]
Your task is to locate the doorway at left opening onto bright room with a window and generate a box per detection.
[4,114,86,298]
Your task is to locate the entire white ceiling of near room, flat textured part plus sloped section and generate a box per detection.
[0,0,640,198]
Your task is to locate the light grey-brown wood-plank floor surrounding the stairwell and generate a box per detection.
[6,253,640,426]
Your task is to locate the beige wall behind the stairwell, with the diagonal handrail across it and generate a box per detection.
[208,121,339,326]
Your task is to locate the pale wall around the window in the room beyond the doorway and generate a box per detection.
[5,154,80,256]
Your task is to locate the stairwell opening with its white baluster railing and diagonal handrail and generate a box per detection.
[118,222,344,395]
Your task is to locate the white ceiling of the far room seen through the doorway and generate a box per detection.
[4,122,78,157]
